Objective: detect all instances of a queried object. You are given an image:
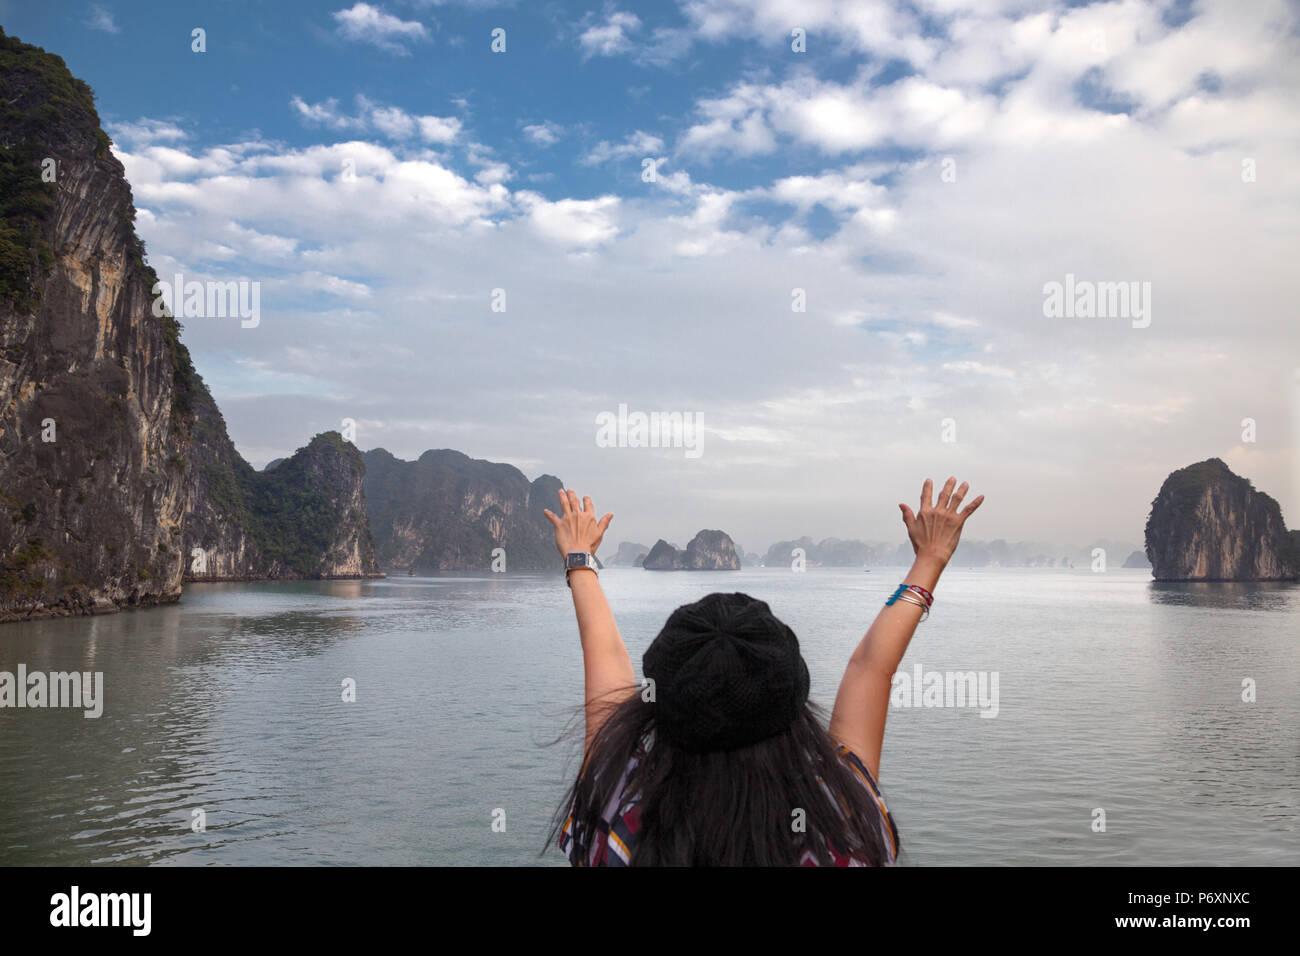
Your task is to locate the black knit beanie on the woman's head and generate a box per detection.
[641,593,809,753]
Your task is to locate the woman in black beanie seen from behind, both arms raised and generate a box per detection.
[546,477,984,866]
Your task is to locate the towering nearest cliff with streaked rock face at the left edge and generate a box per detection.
[0,30,194,619]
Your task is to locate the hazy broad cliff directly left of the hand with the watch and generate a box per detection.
[361,449,563,571]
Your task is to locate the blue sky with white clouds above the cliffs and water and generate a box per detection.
[0,0,1300,559]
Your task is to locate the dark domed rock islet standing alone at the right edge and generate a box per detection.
[1147,458,1300,581]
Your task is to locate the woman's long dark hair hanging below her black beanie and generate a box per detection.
[549,688,893,866]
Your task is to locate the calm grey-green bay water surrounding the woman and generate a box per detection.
[0,568,1300,865]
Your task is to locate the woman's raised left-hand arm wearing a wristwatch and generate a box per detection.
[546,489,637,752]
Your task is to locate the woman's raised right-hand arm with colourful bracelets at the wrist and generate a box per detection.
[831,477,984,779]
